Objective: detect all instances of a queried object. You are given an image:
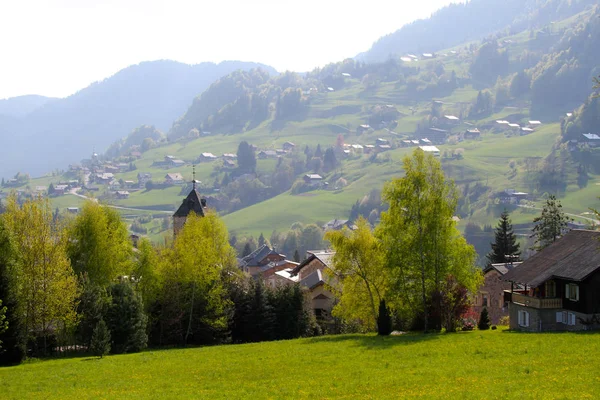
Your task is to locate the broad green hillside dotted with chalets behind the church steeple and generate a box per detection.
[9,8,600,256]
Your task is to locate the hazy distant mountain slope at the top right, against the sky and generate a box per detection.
[356,0,597,62]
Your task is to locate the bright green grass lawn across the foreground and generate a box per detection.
[0,330,600,399]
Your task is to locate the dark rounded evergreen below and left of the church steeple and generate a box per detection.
[105,282,148,354]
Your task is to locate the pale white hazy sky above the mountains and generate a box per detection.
[0,0,457,99]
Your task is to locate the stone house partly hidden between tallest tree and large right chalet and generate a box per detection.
[473,262,521,325]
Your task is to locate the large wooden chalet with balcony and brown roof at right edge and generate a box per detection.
[503,230,600,332]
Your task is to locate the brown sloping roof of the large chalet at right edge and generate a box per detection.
[504,230,600,287]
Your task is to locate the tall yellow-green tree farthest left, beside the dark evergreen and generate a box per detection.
[4,196,78,354]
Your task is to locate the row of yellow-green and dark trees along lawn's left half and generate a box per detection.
[0,196,319,364]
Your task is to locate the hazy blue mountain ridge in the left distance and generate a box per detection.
[0,60,276,177]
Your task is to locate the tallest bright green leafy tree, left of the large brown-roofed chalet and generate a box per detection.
[377,149,481,331]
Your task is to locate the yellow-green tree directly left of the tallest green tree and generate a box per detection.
[325,217,386,329]
